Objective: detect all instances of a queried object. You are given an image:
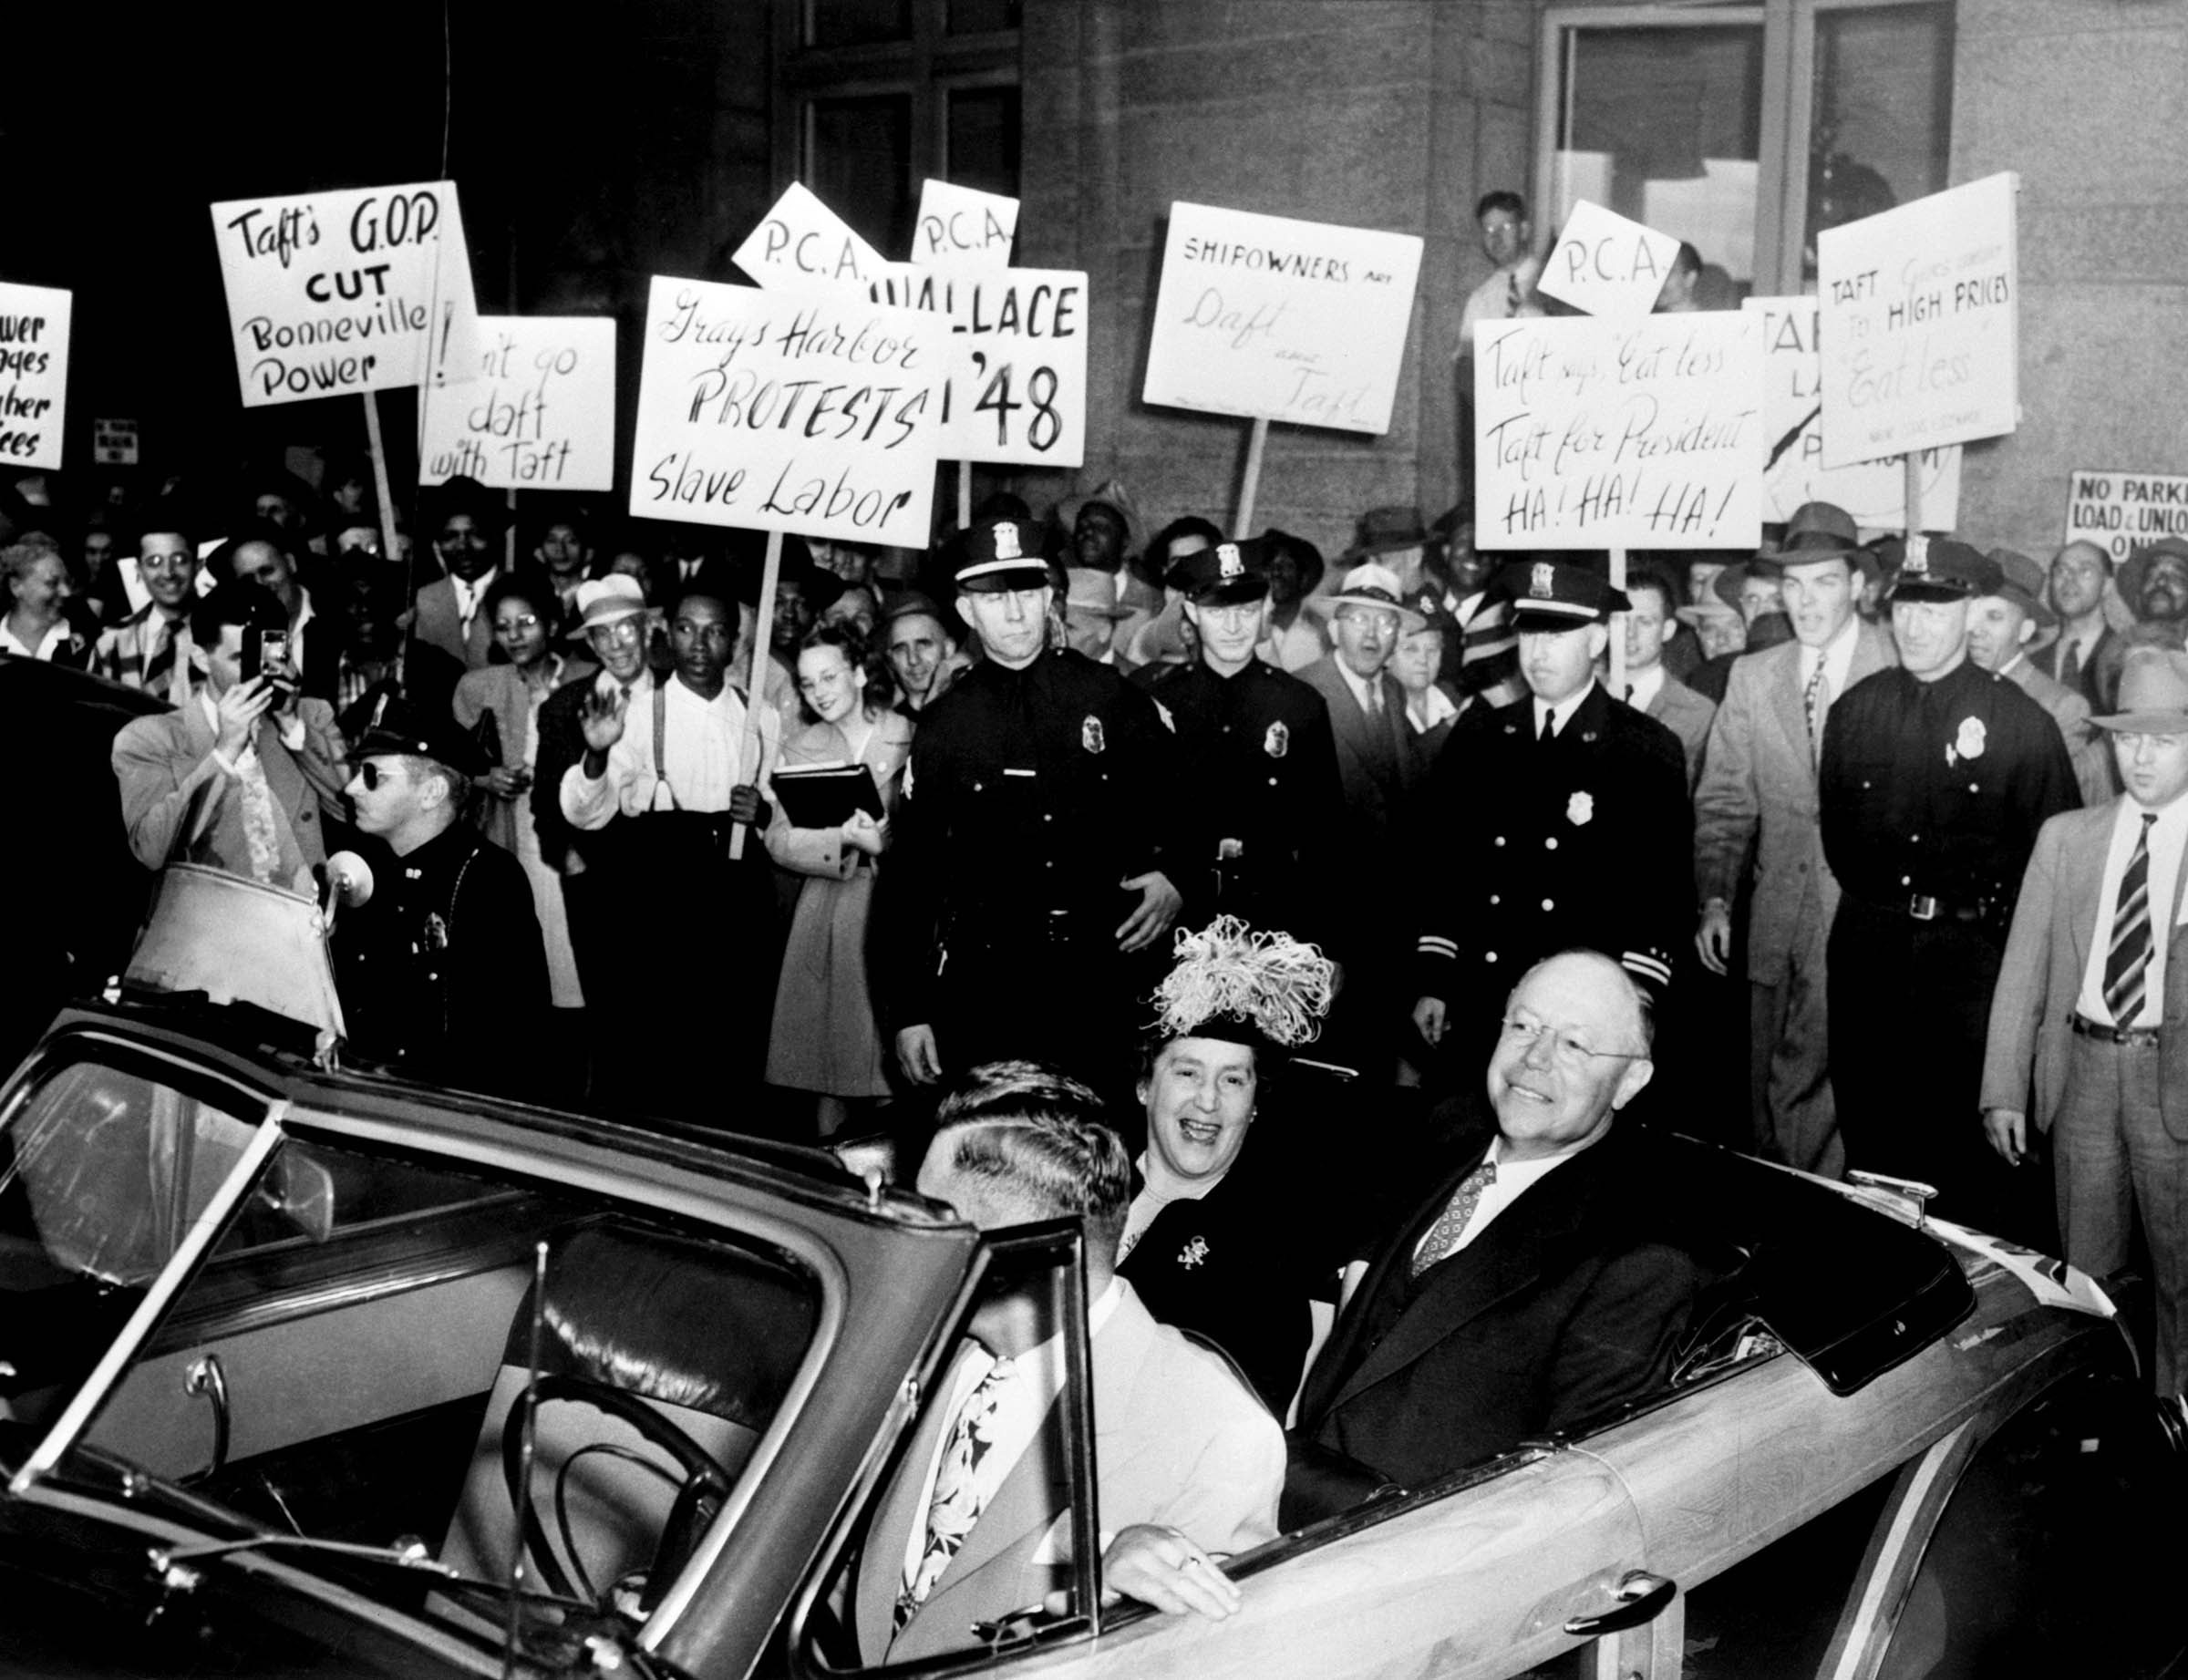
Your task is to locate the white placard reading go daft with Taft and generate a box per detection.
[418,315,614,490]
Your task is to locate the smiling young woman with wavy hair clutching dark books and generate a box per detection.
[768,624,913,1138]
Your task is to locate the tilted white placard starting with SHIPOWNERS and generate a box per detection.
[1142,203,1420,433]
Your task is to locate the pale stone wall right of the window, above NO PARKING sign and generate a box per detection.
[1952,0,2188,558]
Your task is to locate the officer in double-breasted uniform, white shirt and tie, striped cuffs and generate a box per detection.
[1413,556,1694,1067]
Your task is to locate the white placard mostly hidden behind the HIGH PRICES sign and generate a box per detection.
[1741,297,1960,531]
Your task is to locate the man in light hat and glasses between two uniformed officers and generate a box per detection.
[1300,560,1427,864]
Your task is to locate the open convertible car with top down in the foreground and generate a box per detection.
[0,958,2182,1680]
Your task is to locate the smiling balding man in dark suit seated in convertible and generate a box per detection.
[1300,952,1705,1488]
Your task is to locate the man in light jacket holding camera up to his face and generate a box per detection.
[114,582,348,892]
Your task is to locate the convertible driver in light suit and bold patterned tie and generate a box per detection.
[851,1061,1285,1663]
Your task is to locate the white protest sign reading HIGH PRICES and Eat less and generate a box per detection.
[1816,175,2019,466]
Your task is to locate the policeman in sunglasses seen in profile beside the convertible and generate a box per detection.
[335,700,564,1098]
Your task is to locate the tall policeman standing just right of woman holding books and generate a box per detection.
[875,519,1182,1111]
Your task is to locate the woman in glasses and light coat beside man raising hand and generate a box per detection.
[453,571,595,1024]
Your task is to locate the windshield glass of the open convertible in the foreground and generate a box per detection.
[0,1066,820,1656]
